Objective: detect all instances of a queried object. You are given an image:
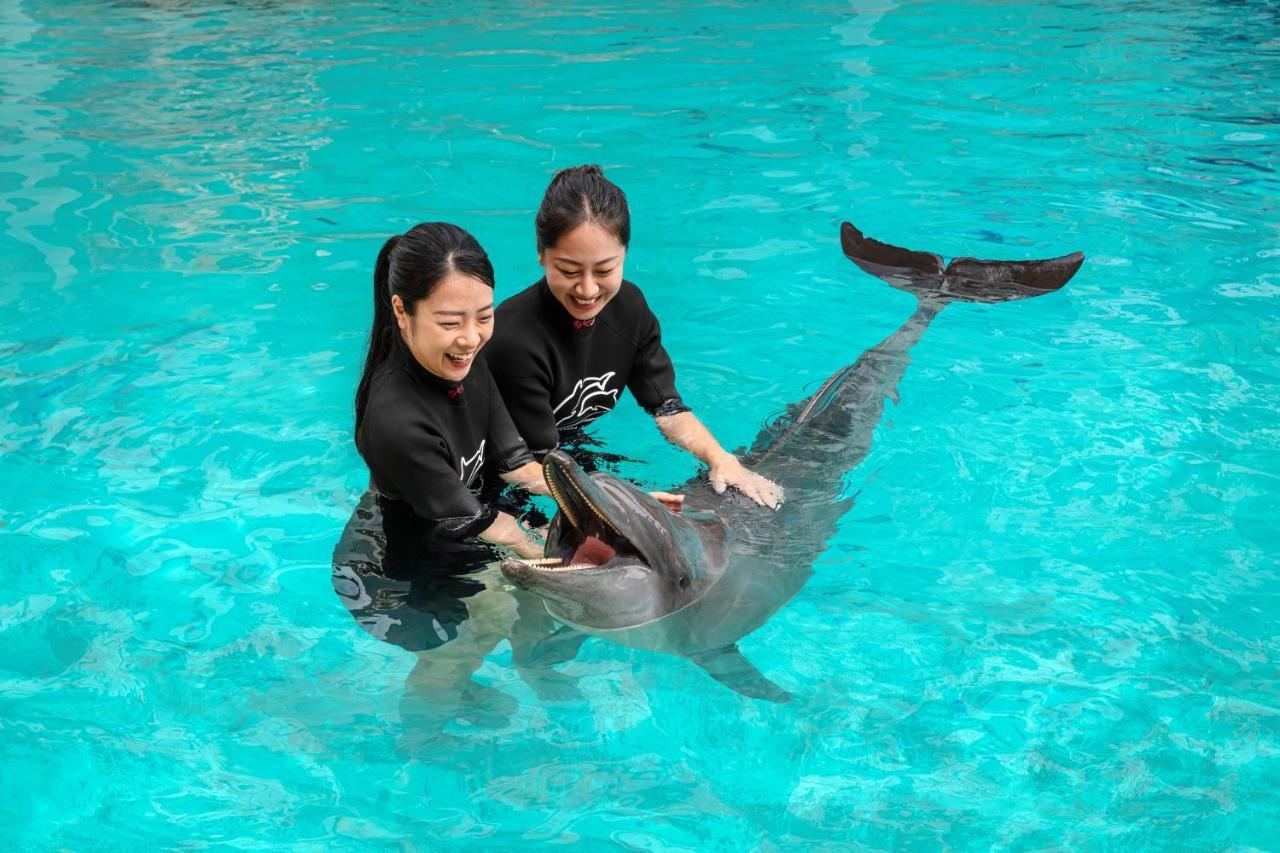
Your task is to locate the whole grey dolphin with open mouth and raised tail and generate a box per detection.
[502,223,1084,702]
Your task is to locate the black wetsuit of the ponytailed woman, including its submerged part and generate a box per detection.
[334,338,532,651]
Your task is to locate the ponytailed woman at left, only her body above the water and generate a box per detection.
[356,223,545,556]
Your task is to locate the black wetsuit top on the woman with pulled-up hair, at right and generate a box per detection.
[484,278,689,459]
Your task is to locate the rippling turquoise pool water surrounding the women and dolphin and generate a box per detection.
[0,0,1280,850]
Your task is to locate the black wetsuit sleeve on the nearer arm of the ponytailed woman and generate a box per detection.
[366,424,498,539]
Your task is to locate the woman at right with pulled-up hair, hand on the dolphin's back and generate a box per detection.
[485,165,782,508]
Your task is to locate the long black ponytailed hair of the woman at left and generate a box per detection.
[356,222,493,435]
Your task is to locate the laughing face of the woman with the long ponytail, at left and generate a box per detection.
[392,272,493,382]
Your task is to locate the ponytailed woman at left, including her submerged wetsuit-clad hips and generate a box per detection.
[334,223,547,649]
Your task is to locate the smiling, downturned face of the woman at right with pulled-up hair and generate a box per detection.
[538,222,627,320]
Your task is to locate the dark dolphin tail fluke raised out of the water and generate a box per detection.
[840,222,1084,302]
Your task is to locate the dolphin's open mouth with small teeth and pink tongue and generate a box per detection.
[503,451,645,575]
